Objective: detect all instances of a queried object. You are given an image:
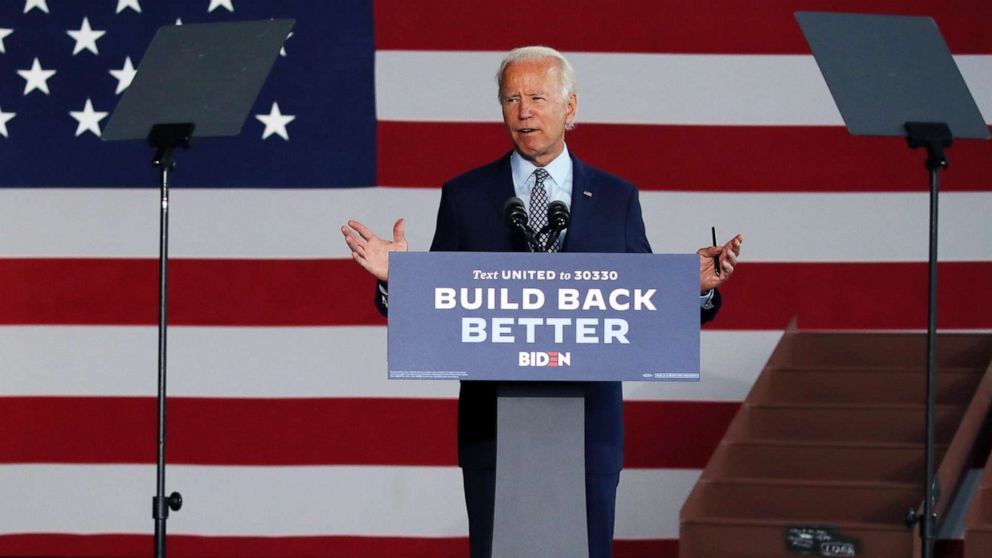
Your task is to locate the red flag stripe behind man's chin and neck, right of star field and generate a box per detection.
[377,122,992,192]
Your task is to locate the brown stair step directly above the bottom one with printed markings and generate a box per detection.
[699,479,921,525]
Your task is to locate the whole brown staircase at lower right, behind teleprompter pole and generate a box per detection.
[679,328,992,558]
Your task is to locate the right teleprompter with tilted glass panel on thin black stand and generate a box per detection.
[796,12,990,558]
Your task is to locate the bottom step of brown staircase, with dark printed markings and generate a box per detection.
[679,518,915,558]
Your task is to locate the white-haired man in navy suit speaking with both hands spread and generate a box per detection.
[342,47,743,558]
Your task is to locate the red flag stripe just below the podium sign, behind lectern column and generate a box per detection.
[0,397,739,469]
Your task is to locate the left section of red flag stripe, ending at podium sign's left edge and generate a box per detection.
[0,259,386,326]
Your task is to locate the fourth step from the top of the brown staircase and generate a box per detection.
[708,440,945,482]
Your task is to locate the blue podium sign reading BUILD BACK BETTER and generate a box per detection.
[388,252,699,381]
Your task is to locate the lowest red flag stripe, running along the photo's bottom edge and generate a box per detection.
[0,534,678,558]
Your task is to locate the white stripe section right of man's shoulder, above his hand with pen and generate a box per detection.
[642,192,992,265]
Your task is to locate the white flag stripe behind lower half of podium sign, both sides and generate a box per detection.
[0,326,781,401]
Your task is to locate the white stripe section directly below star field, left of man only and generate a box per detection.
[0,188,441,258]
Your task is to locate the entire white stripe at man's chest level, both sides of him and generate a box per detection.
[0,189,992,262]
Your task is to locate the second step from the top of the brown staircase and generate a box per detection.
[768,368,984,405]
